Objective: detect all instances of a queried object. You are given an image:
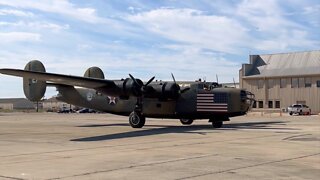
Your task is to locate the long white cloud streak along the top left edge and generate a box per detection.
[0,0,105,23]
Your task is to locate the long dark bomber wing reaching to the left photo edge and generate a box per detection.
[0,69,117,89]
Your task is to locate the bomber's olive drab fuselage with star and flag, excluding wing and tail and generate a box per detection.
[57,82,250,119]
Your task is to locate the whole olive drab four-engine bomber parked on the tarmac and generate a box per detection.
[0,60,254,128]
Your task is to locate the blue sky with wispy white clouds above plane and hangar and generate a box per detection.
[0,0,320,98]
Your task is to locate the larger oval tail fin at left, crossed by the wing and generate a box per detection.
[23,60,47,101]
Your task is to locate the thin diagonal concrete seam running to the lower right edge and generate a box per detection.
[175,153,320,180]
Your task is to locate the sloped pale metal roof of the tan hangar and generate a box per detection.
[246,50,320,78]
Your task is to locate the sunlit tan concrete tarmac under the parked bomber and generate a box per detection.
[0,113,320,180]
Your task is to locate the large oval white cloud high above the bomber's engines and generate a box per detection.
[128,9,247,52]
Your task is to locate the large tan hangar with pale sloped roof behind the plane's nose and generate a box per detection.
[239,50,320,114]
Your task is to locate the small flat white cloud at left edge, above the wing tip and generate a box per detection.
[0,32,41,44]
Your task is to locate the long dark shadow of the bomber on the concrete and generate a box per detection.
[70,121,297,142]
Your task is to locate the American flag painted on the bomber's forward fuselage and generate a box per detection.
[197,92,228,112]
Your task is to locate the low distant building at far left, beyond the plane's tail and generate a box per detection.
[0,98,35,110]
